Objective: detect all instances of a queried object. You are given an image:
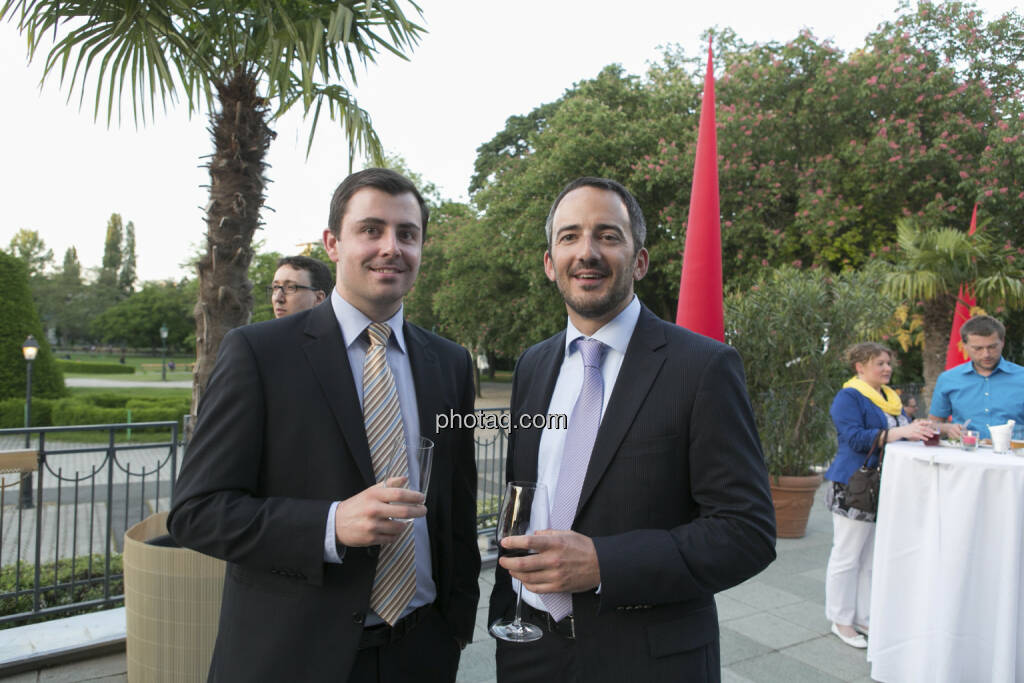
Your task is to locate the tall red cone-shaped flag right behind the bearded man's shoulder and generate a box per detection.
[676,41,725,341]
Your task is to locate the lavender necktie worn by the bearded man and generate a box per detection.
[541,337,607,622]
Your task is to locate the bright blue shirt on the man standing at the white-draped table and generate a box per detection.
[929,358,1024,438]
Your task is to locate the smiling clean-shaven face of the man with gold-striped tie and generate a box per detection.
[324,187,423,322]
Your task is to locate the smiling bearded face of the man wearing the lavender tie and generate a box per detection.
[544,185,648,335]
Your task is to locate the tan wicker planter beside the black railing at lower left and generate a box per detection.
[124,512,224,683]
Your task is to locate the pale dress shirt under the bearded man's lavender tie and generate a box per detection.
[520,295,640,611]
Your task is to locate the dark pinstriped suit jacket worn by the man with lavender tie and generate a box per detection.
[489,308,775,681]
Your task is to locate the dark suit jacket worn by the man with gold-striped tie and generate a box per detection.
[168,301,480,681]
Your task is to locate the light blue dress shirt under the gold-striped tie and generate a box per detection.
[324,289,437,627]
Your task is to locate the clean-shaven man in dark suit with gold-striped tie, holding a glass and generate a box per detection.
[168,169,480,683]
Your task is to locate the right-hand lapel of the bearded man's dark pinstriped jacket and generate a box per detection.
[581,307,666,516]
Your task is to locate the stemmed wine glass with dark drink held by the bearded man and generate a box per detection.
[490,481,548,643]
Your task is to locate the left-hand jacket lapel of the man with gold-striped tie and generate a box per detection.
[302,300,375,486]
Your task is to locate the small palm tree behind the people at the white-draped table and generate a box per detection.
[884,219,1024,404]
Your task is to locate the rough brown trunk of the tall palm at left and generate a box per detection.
[191,68,274,417]
